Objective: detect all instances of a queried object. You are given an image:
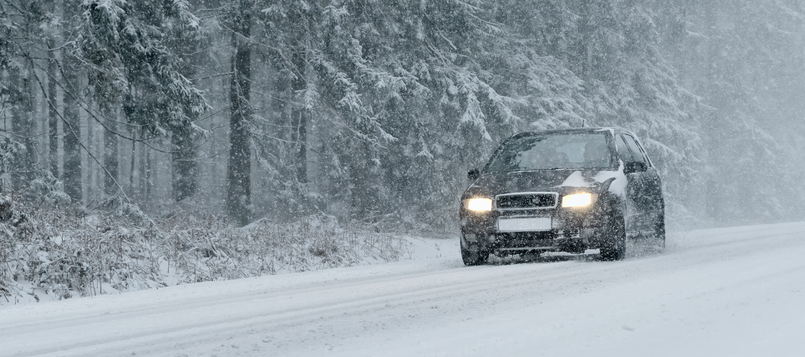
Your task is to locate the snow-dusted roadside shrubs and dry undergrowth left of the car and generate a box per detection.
[0,197,413,304]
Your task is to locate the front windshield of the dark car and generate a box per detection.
[487,133,612,172]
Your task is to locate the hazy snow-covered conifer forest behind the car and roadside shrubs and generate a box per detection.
[0,0,805,230]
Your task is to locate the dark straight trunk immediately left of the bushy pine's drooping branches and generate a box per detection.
[62,0,83,202]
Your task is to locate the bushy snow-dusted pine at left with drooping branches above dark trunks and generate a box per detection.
[78,0,207,200]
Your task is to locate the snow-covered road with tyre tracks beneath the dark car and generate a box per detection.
[0,223,805,356]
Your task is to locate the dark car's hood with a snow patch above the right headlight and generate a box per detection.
[465,169,626,196]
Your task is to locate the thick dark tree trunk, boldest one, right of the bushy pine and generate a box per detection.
[226,0,253,225]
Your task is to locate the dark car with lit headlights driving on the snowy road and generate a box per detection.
[459,128,665,265]
